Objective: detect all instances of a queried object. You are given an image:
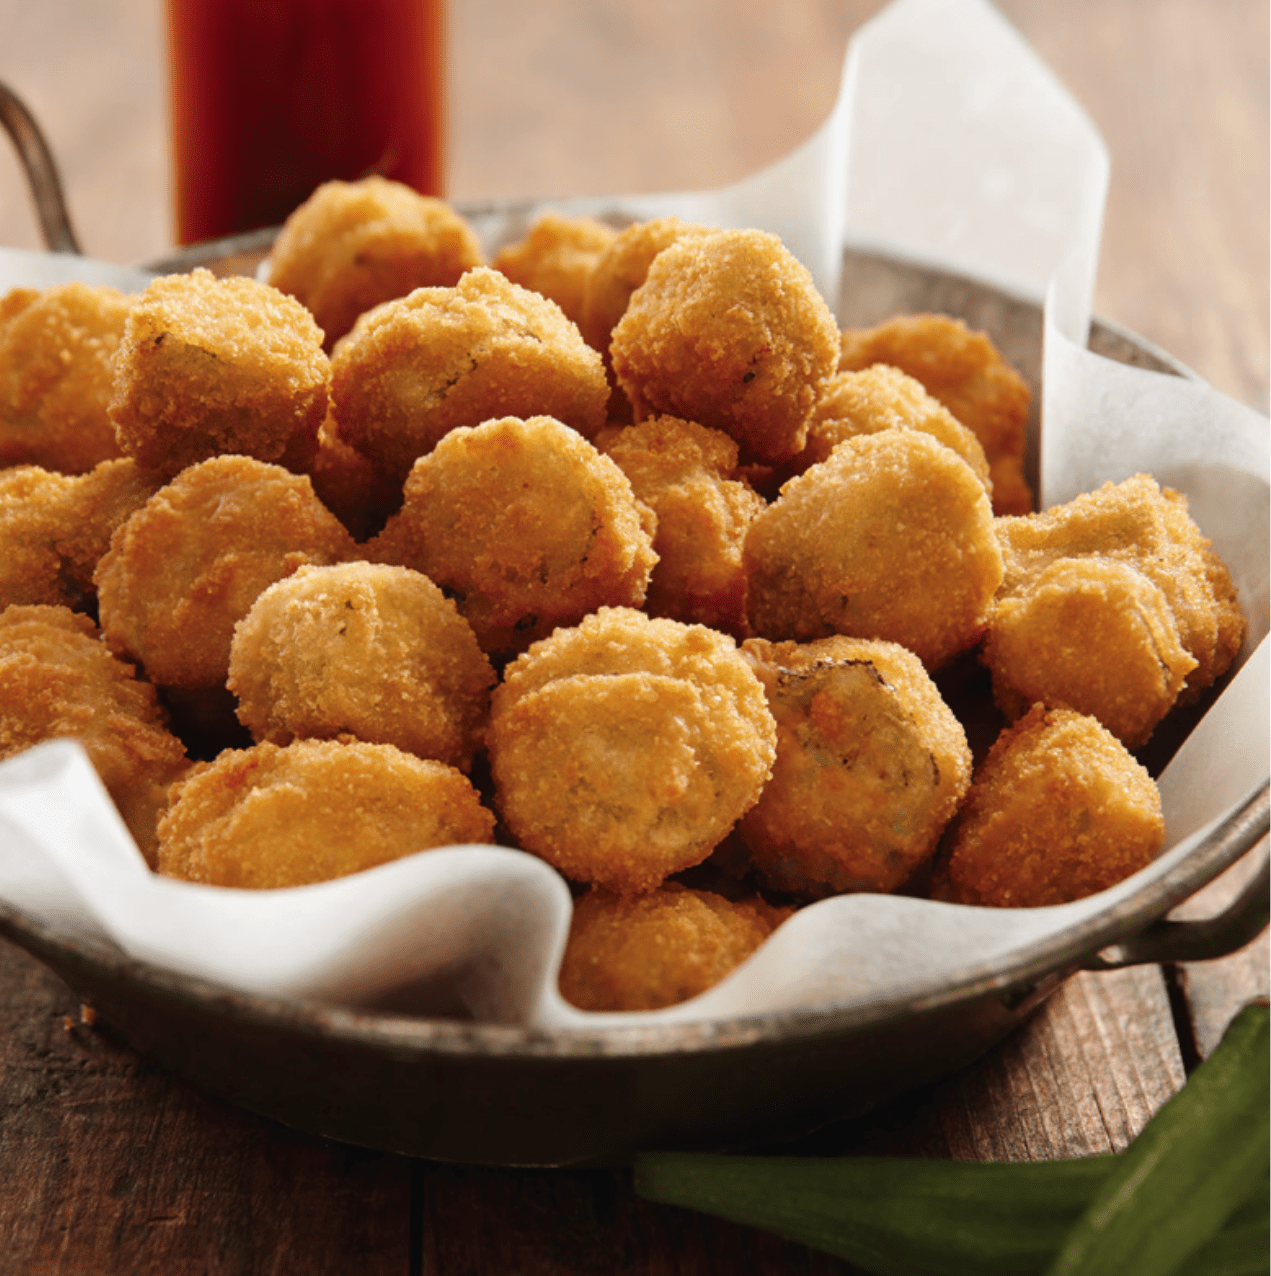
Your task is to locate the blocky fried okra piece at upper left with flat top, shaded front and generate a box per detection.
[110,269,331,477]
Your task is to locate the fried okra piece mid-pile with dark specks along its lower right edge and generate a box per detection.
[366,416,657,653]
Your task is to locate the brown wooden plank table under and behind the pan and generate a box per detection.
[0,0,1271,1276]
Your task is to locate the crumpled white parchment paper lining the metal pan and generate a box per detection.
[0,0,1271,1028]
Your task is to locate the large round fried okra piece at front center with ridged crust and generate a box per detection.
[486,607,776,894]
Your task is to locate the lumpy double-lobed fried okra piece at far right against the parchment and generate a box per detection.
[981,475,1245,748]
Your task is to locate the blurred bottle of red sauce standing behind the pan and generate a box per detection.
[167,0,445,244]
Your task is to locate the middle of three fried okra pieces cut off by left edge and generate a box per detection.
[0,457,162,611]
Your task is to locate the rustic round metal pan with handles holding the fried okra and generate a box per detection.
[0,85,1271,1165]
